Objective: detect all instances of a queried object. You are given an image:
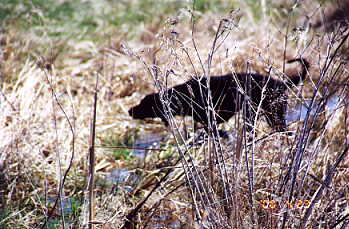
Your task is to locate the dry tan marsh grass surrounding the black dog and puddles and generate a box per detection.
[0,2,349,228]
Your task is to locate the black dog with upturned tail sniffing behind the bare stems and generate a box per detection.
[128,58,309,131]
